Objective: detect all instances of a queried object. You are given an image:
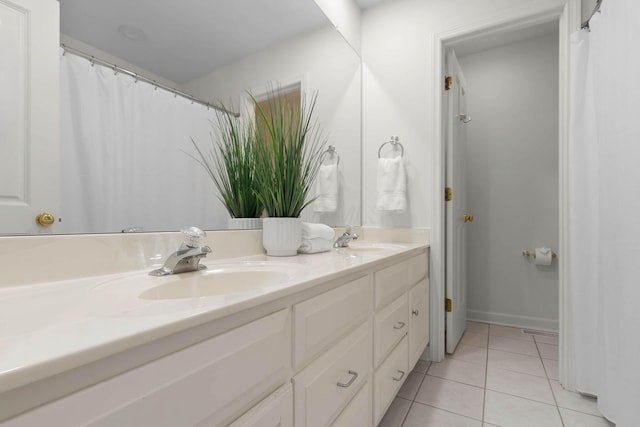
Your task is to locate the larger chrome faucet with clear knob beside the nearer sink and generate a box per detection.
[149,227,211,276]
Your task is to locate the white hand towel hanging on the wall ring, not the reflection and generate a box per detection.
[376,157,407,212]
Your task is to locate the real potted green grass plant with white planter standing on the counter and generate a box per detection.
[251,90,326,256]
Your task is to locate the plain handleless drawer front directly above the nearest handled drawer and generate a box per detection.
[293,275,371,369]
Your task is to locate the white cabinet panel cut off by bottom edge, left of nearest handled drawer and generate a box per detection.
[228,384,293,427]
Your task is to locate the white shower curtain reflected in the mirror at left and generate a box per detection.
[60,53,229,233]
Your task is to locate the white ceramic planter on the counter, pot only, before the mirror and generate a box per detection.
[262,218,302,256]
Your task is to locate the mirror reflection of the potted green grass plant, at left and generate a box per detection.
[187,108,263,229]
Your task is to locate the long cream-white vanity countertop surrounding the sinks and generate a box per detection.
[0,242,428,393]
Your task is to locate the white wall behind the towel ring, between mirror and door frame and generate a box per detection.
[362,0,563,231]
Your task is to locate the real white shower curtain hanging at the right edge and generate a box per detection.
[570,0,640,426]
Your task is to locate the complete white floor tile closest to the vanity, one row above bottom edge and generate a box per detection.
[416,375,484,420]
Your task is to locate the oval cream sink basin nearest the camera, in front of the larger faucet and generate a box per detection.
[139,268,289,300]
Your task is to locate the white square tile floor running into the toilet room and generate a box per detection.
[380,322,613,427]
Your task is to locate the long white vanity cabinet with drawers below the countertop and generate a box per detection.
[0,246,429,427]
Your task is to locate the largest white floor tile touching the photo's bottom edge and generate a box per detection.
[484,390,562,427]
